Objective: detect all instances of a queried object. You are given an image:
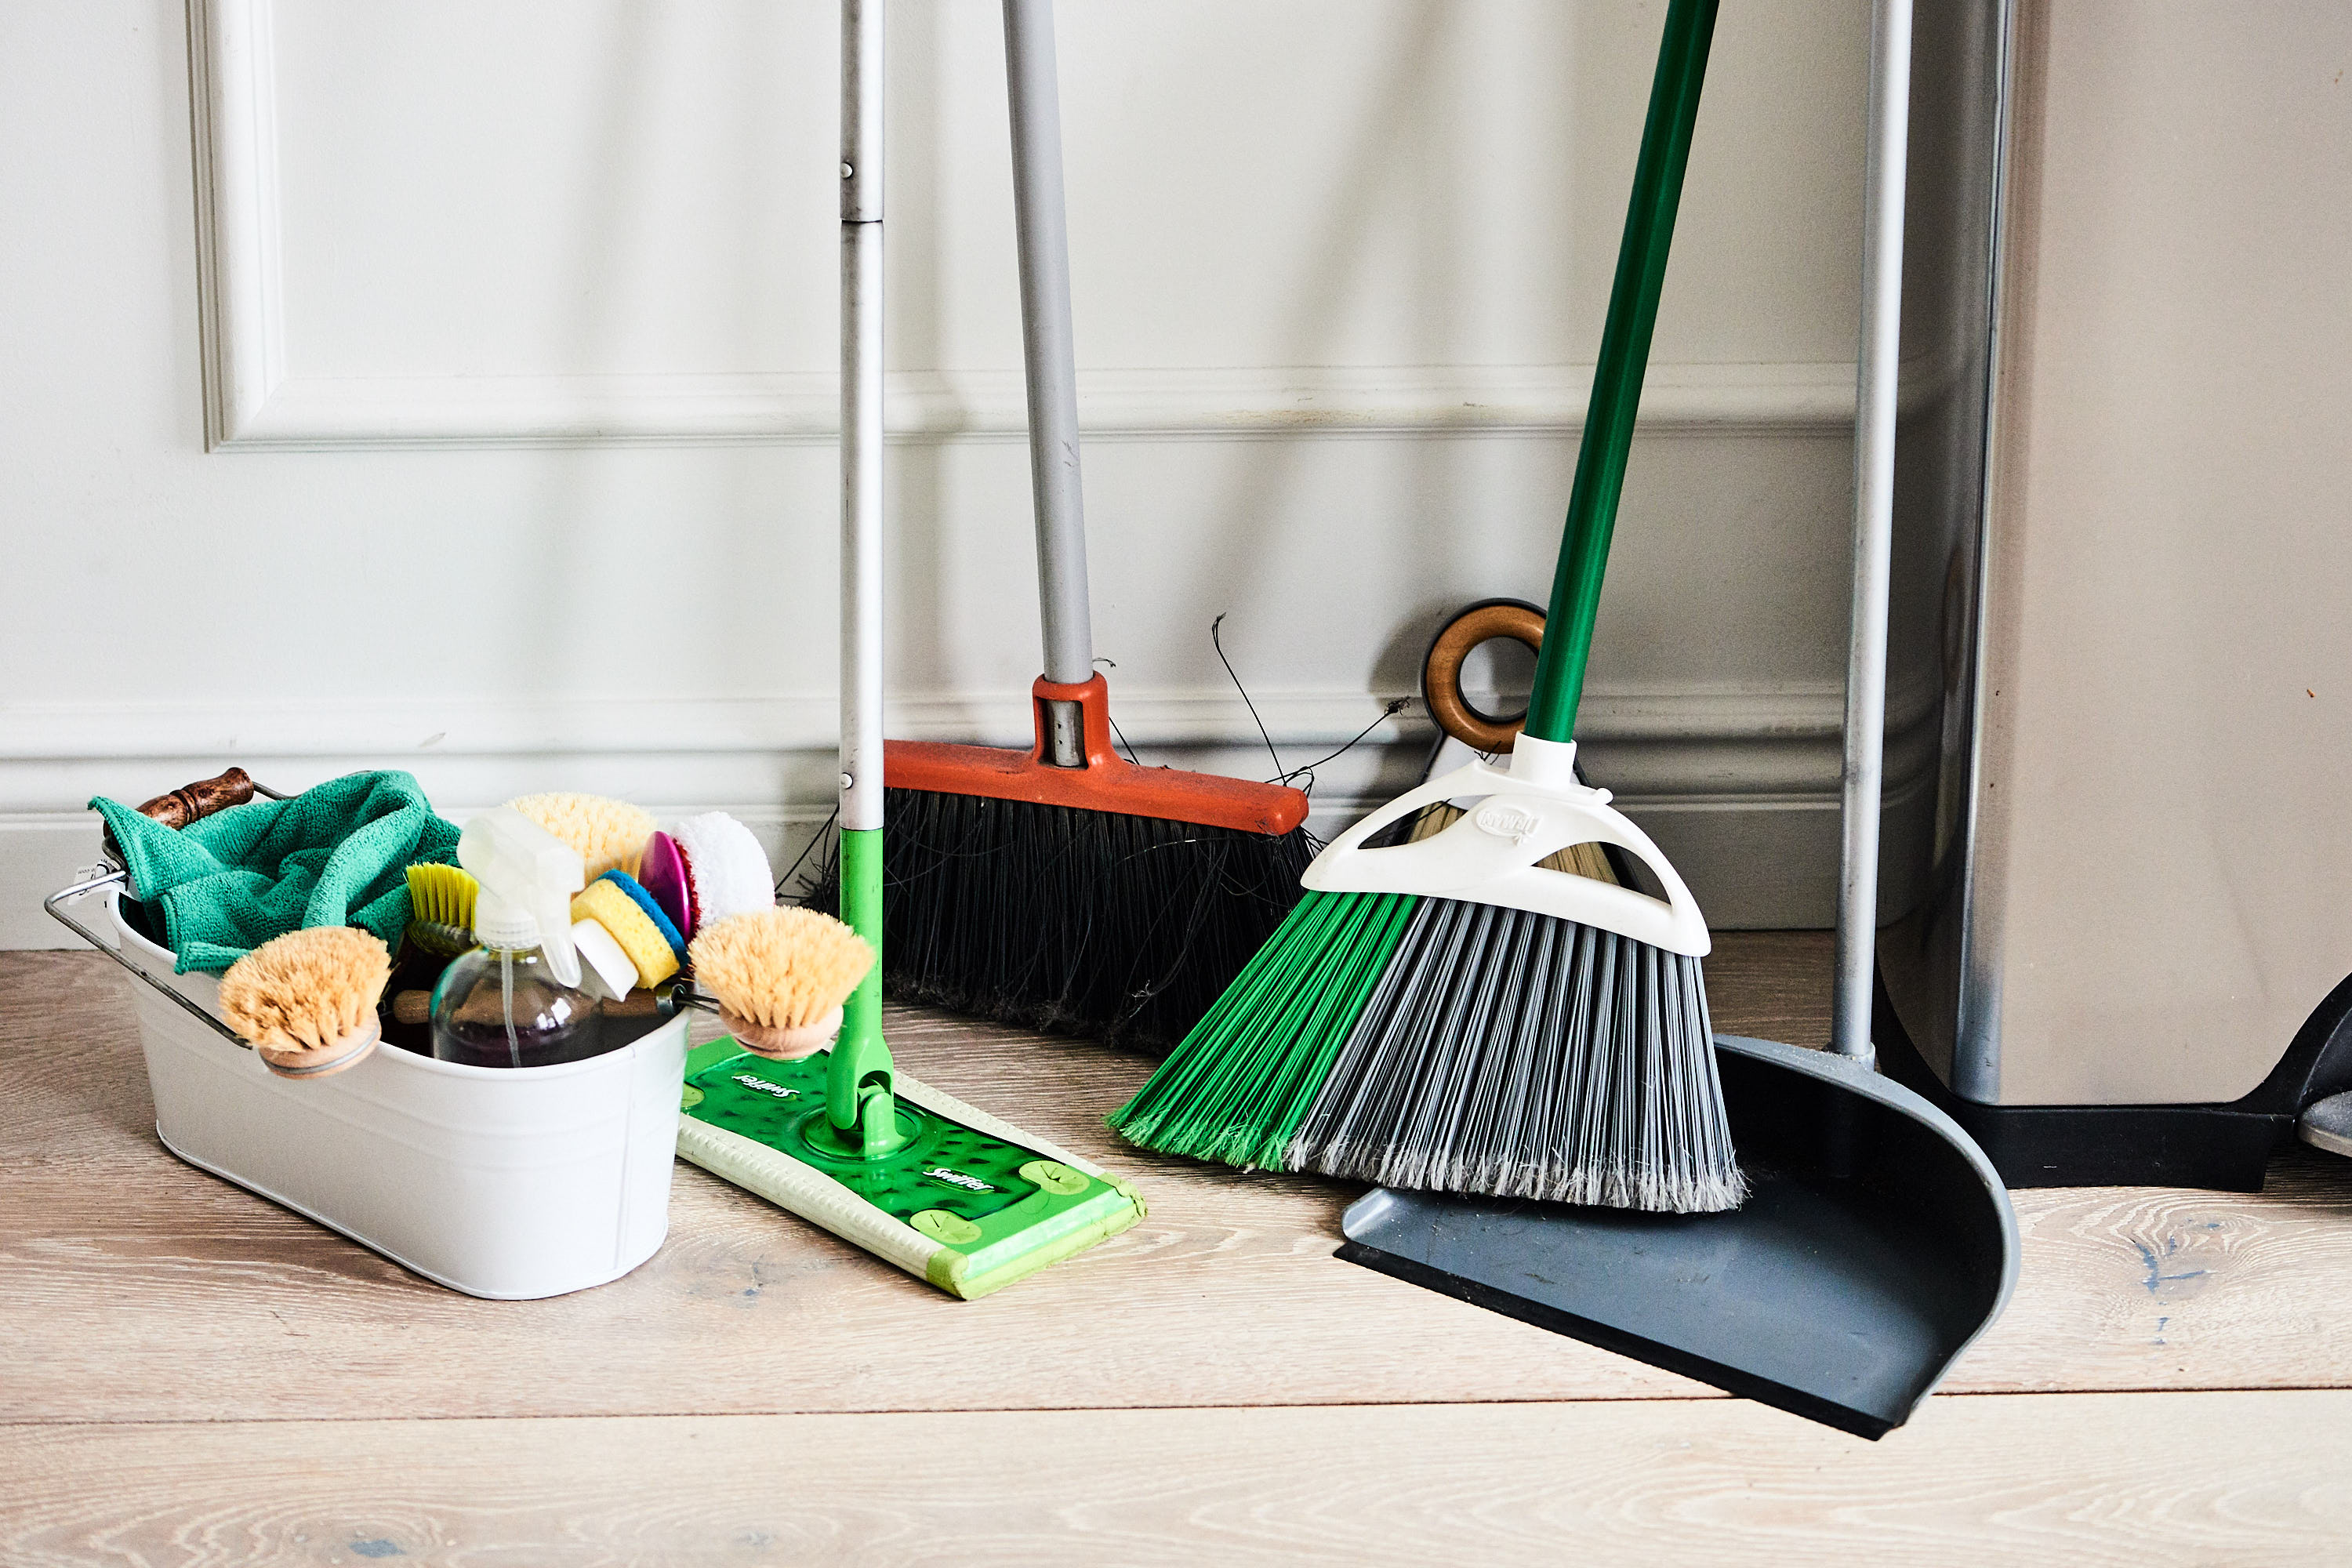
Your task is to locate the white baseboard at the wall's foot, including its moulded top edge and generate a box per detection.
[0,687,1872,947]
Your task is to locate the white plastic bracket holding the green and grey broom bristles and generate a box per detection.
[1301,736,1712,959]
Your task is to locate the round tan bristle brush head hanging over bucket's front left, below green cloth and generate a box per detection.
[221,926,393,1079]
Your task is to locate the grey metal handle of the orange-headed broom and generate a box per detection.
[1004,0,1094,767]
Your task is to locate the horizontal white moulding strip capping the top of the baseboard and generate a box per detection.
[0,684,1938,811]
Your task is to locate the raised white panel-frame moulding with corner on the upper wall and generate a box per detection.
[188,0,1853,452]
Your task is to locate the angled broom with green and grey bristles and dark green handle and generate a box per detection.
[1110,0,1748,1213]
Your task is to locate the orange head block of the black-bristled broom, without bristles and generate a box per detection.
[882,675,1308,834]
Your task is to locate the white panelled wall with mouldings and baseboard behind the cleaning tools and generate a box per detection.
[0,0,1867,942]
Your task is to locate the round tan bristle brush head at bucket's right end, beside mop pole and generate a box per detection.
[691,907,875,1060]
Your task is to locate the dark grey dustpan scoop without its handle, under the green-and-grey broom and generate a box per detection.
[1338,1034,2018,1439]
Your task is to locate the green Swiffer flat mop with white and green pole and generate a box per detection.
[677,0,1143,1300]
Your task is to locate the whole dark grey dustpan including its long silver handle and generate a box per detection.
[1338,0,2018,1439]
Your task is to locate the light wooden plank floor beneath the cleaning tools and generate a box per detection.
[0,933,2352,1563]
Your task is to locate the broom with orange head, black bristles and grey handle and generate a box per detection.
[851,0,1312,1051]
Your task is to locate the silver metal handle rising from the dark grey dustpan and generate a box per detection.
[1830,0,1912,1062]
